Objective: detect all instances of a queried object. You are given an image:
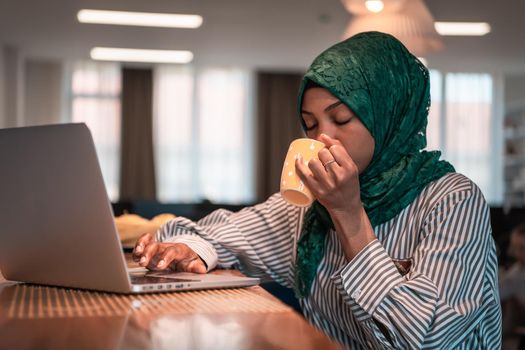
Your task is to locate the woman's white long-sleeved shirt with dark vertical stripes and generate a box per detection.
[157,173,501,349]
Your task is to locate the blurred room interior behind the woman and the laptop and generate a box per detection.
[0,0,525,344]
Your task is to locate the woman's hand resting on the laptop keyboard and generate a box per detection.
[133,233,206,273]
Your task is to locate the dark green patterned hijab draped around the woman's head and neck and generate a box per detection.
[295,32,454,297]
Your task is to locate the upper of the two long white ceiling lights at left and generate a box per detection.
[77,9,202,28]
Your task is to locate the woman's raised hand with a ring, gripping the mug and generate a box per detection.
[295,134,362,213]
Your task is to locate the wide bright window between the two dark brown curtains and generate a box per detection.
[154,66,254,203]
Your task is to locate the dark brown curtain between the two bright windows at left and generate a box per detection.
[120,68,156,201]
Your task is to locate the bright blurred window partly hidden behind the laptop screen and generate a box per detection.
[71,62,121,201]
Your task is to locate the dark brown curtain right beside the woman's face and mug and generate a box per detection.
[256,72,304,201]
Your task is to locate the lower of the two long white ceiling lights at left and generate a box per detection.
[91,47,193,63]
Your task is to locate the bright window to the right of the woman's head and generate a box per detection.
[427,71,503,203]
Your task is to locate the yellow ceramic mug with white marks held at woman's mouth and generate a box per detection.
[281,138,325,207]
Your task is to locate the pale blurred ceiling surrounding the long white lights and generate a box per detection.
[0,0,525,73]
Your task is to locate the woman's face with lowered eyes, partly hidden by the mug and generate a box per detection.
[301,87,375,173]
